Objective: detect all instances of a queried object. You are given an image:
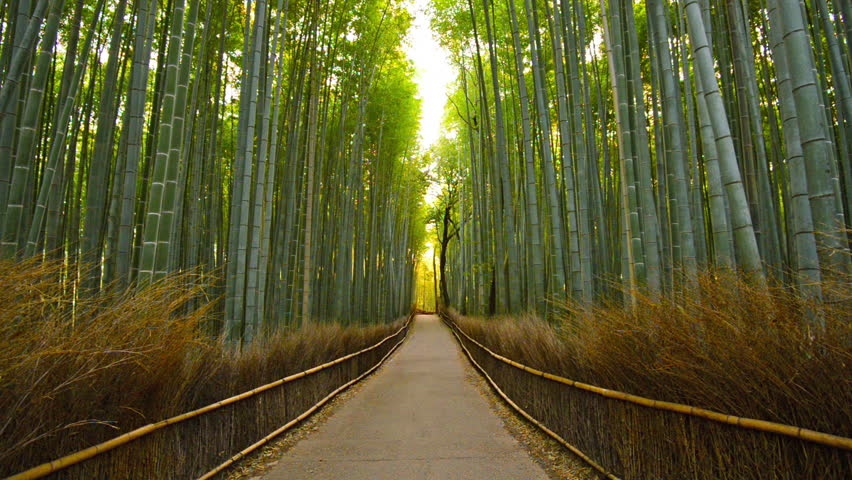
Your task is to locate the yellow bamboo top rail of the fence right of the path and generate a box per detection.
[447,319,852,451]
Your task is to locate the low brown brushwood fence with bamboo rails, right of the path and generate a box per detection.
[445,317,852,480]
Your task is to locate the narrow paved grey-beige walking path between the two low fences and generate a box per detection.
[263,315,547,480]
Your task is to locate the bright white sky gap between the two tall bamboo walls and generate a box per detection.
[405,0,456,150]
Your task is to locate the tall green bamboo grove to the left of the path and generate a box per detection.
[0,0,426,343]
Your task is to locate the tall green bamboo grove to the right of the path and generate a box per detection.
[431,0,852,313]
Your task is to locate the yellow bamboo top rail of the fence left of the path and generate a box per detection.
[6,315,413,480]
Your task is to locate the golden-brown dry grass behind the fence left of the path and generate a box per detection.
[0,262,398,478]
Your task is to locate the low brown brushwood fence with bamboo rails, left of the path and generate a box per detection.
[7,316,413,480]
